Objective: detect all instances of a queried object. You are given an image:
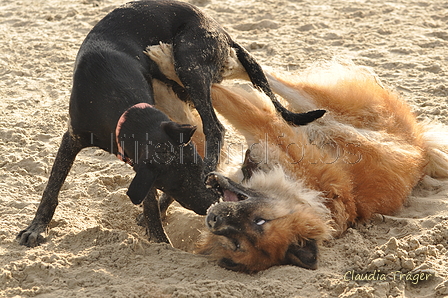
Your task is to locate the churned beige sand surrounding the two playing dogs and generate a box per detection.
[0,0,448,298]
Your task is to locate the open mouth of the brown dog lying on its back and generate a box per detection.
[205,172,250,209]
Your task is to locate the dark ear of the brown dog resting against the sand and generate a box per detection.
[285,239,319,270]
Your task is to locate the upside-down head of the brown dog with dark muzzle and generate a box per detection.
[197,169,331,272]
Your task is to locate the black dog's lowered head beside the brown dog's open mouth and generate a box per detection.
[120,108,218,215]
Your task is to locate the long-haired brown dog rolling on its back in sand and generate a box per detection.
[149,48,448,272]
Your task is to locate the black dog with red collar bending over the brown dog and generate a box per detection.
[18,0,323,246]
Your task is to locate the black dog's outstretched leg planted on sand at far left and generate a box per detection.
[17,131,85,247]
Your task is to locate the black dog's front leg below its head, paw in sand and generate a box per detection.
[143,188,170,243]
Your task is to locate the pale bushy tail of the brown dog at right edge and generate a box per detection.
[422,121,448,178]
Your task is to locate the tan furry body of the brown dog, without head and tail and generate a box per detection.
[208,63,442,231]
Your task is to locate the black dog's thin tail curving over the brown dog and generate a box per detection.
[232,42,326,125]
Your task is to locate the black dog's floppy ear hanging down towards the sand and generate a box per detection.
[126,164,157,205]
